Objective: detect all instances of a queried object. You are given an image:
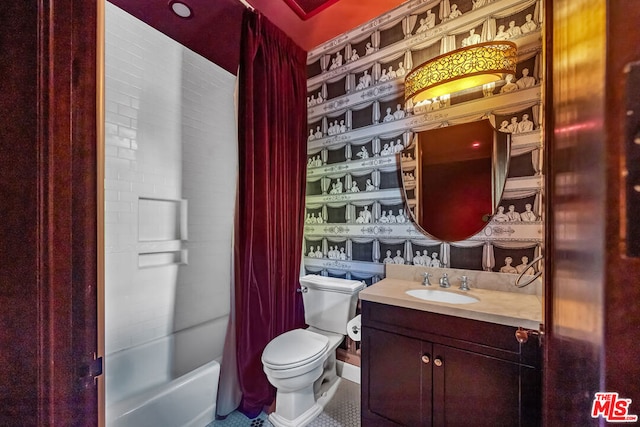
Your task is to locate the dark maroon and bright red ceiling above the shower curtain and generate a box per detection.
[108,0,405,74]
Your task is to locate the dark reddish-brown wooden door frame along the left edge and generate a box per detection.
[0,0,98,426]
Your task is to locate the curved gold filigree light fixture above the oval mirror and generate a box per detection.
[404,41,518,105]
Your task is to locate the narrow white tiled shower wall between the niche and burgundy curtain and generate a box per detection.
[174,50,238,375]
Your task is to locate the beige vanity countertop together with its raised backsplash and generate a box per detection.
[360,264,542,330]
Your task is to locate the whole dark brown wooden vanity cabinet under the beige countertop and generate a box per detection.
[362,301,541,427]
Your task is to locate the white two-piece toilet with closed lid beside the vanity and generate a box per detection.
[262,274,366,427]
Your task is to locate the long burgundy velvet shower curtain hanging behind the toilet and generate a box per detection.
[234,10,307,417]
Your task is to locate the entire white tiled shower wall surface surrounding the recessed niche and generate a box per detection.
[104,2,237,388]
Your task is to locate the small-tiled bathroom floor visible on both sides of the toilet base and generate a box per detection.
[206,379,360,427]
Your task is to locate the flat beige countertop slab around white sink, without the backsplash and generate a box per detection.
[360,278,542,330]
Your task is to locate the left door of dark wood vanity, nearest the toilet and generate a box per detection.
[362,328,432,426]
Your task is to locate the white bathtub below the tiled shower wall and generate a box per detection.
[106,343,220,427]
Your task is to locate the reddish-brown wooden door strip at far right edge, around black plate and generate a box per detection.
[602,0,640,416]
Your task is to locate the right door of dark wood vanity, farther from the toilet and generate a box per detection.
[433,344,524,427]
